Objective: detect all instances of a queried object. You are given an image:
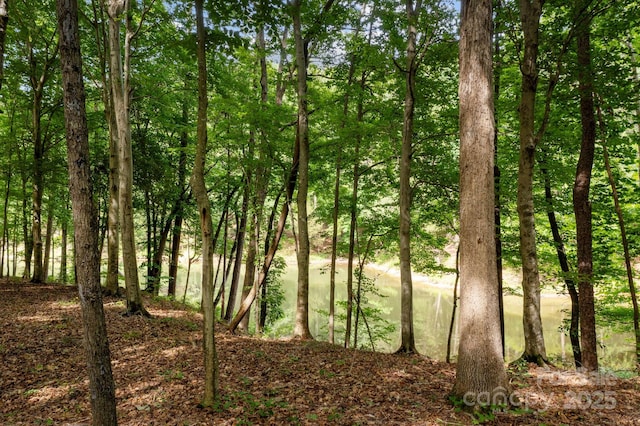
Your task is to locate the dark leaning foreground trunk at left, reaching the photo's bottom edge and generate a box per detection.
[56,0,117,426]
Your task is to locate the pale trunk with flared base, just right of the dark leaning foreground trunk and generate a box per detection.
[107,0,149,316]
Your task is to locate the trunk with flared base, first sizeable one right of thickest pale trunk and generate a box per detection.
[518,0,547,365]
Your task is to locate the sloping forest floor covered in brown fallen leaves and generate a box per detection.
[0,280,640,426]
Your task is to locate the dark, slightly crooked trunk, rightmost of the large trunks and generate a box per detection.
[573,0,598,371]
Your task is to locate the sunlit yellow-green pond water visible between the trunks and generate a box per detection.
[168,260,635,370]
